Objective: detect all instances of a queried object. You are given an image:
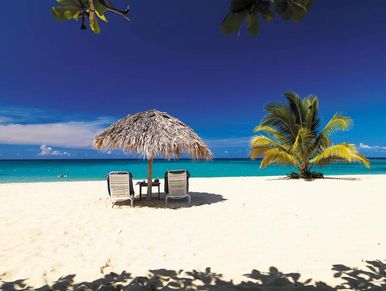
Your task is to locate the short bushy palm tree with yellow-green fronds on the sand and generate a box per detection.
[250,92,370,178]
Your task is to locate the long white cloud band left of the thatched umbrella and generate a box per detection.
[0,119,107,148]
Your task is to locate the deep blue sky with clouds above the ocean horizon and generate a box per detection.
[0,0,386,158]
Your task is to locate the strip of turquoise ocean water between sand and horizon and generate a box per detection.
[0,159,386,183]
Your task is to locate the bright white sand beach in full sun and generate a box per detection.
[0,175,386,289]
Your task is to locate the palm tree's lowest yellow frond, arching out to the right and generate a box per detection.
[310,143,370,168]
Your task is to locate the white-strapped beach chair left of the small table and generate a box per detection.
[106,172,134,207]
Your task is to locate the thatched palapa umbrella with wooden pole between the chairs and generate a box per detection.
[94,109,213,197]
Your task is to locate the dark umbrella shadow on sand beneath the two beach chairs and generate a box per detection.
[115,192,226,209]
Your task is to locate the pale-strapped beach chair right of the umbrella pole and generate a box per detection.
[166,170,192,204]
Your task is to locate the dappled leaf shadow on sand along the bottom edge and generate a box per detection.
[0,260,386,291]
